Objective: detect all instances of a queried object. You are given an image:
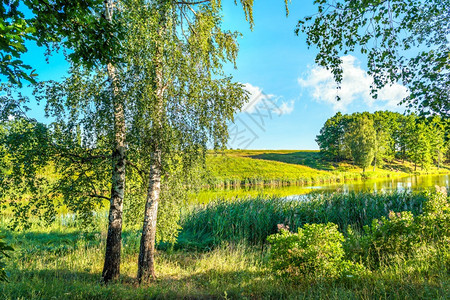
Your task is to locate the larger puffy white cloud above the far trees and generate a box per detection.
[298,55,408,111]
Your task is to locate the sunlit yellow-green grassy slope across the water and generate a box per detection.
[207,150,450,185]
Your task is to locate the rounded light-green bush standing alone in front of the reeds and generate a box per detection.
[267,223,364,279]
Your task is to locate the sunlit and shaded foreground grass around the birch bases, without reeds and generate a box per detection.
[0,233,449,299]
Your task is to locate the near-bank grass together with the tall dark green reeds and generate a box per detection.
[0,193,450,299]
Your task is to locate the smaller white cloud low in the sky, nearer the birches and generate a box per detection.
[241,83,294,115]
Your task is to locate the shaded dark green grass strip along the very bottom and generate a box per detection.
[0,270,448,299]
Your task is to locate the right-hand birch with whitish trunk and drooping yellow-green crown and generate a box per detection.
[116,1,251,282]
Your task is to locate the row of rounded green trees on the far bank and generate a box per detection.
[316,111,450,171]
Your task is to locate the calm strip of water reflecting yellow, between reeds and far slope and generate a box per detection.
[196,174,450,203]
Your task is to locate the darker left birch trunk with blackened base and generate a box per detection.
[102,0,126,283]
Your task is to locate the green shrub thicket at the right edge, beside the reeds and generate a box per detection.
[345,188,450,268]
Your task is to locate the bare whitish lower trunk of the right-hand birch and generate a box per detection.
[138,152,161,283]
